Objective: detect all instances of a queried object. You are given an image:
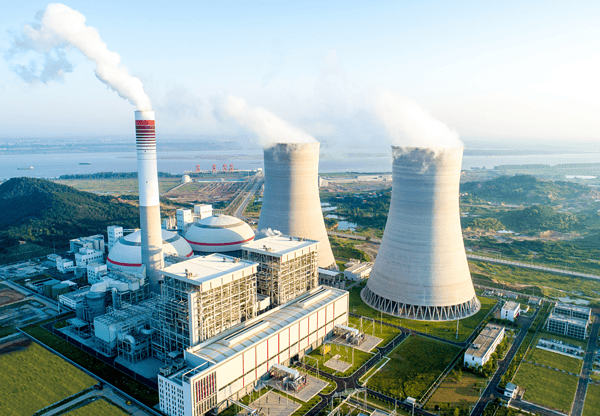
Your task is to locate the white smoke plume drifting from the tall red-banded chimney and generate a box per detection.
[7,3,152,110]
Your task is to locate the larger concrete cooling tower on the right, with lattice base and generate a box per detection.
[361,147,481,321]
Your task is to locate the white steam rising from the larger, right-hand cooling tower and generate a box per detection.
[374,90,464,149]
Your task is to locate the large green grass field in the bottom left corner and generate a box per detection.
[0,343,96,415]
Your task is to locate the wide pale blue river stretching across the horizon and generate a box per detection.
[0,149,600,179]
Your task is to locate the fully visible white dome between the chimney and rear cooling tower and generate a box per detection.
[185,215,254,253]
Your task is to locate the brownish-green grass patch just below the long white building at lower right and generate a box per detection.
[427,372,485,414]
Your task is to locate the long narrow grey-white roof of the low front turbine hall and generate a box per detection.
[185,286,348,364]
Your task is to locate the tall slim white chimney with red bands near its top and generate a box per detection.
[135,111,163,293]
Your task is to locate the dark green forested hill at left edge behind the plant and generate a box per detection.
[0,178,139,252]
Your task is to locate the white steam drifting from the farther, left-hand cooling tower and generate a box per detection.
[224,95,317,147]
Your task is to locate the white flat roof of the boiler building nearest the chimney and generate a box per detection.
[161,254,258,288]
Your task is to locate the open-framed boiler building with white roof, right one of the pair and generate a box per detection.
[242,235,320,306]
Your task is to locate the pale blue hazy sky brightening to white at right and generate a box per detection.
[0,0,600,149]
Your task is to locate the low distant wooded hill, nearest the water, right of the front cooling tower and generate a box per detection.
[460,175,595,204]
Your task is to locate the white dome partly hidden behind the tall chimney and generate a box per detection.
[106,230,192,268]
